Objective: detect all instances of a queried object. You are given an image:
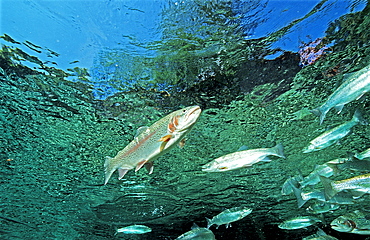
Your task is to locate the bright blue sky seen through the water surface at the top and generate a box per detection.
[0,0,364,85]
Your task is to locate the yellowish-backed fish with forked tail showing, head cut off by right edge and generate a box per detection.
[320,173,370,200]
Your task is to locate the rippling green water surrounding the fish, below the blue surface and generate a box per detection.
[0,1,370,239]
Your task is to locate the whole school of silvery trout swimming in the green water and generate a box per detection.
[104,62,370,237]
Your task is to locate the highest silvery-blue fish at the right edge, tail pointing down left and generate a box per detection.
[312,65,370,124]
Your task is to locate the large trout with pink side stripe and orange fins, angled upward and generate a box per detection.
[104,106,201,184]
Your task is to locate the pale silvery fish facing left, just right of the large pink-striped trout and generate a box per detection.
[202,144,285,172]
